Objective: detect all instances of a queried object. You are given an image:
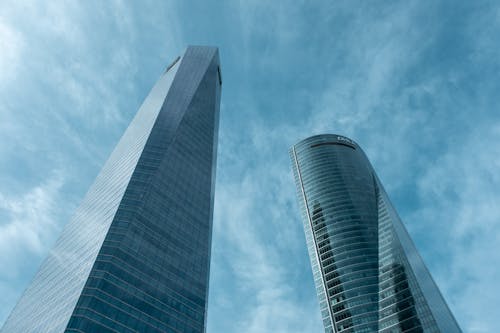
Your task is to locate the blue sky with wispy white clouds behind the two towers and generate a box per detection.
[0,0,500,333]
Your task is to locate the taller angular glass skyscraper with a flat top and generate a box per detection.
[1,46,222,333]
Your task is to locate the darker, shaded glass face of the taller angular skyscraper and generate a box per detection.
[67,48,220,333]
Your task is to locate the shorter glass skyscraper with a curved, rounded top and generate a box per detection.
[290,134,461,333]
